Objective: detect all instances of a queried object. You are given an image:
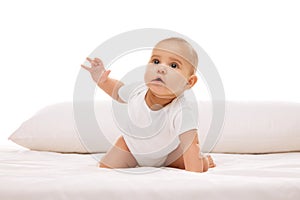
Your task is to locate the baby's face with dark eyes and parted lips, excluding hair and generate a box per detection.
[144,47,195,97]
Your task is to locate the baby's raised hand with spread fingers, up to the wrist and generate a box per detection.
[81,58,111,83]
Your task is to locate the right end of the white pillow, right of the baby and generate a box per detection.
[204,101,300,153]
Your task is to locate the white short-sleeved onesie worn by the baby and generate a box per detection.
[118,83,198,167]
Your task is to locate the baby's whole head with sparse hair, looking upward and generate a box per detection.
[144,38,198,98]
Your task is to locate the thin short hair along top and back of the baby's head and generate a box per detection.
[156,37,198,74]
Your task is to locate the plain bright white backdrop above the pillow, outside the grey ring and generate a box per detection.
[0,0,300,144]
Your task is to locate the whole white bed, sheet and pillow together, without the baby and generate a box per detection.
[0,102,300,200]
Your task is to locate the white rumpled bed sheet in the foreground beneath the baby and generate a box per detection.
[0,144,300,200]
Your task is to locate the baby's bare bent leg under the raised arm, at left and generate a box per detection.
[99,136,137,168]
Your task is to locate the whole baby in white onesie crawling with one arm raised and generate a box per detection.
[81,37,215,172]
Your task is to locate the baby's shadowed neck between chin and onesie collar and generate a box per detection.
[145,89,176,111]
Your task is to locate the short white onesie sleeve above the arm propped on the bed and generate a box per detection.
[173,101,198,135]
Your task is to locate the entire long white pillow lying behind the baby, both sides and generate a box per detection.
[9,101,300,153]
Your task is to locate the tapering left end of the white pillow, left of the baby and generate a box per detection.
[9,102,111,153]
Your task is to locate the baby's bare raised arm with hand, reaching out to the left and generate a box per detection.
[81,58,125,103]
